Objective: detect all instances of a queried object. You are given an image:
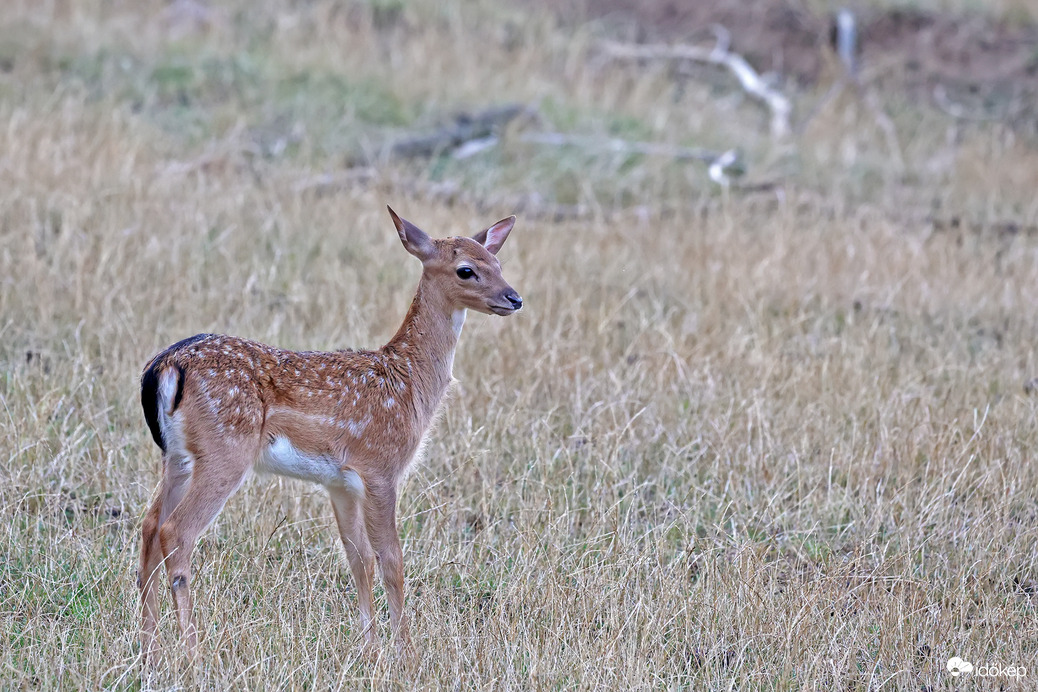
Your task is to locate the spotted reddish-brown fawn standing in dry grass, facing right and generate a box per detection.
[137,209,522,660]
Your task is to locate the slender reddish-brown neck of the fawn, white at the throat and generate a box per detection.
[382,275,465,421]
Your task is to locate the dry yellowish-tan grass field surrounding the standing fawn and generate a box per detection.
[0,0,1038,690]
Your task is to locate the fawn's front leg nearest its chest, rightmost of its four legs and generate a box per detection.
[364,482,410,651]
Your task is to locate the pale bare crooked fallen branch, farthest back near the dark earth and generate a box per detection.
[600,33,793,139]
